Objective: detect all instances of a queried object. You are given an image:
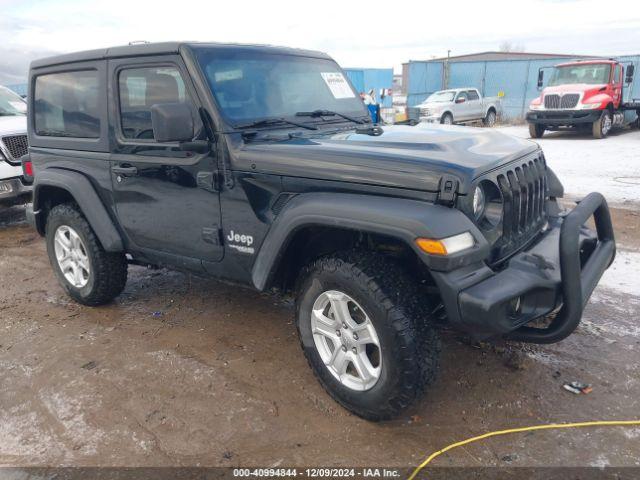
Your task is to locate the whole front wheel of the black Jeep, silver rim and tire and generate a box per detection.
[296,251,440,421]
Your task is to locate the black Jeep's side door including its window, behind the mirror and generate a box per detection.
[109,56,223,269]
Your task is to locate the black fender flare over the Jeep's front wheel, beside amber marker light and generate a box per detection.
[252,193,489,290]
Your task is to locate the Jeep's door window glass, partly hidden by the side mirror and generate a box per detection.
[118,67,197,140]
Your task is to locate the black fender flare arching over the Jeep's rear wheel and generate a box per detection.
[33,168,124,252]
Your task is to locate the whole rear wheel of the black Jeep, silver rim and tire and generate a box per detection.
[46,204,127,306]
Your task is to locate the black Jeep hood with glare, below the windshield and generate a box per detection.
[232,124,538,194]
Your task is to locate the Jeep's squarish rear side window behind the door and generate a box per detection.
[34,70,100,138]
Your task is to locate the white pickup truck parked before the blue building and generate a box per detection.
[417,88,501,127]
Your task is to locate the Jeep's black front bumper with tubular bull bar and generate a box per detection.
[433,193,616,343]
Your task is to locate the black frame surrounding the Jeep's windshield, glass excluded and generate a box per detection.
[188,44,371,133]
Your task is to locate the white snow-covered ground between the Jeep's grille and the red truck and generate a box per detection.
[498,126,640,207]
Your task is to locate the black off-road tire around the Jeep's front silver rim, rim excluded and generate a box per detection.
[296,250,440,421]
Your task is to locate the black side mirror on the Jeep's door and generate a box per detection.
[151,103,194,142]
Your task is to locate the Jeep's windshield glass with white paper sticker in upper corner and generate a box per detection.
[194,47,367,124]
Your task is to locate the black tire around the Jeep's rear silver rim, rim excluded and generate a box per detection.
[45,203,127,306]
